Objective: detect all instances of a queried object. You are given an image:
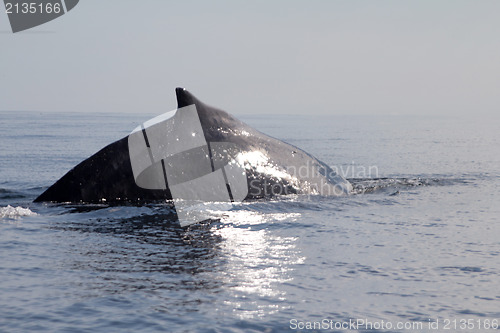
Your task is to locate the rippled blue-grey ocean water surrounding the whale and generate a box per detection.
[0,112,500,332]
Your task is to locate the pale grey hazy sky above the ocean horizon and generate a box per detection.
[0,0,500,115]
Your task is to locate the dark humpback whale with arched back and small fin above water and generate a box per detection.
[35,88,352,223]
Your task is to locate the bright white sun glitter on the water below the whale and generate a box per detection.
[214,210,305,319]
